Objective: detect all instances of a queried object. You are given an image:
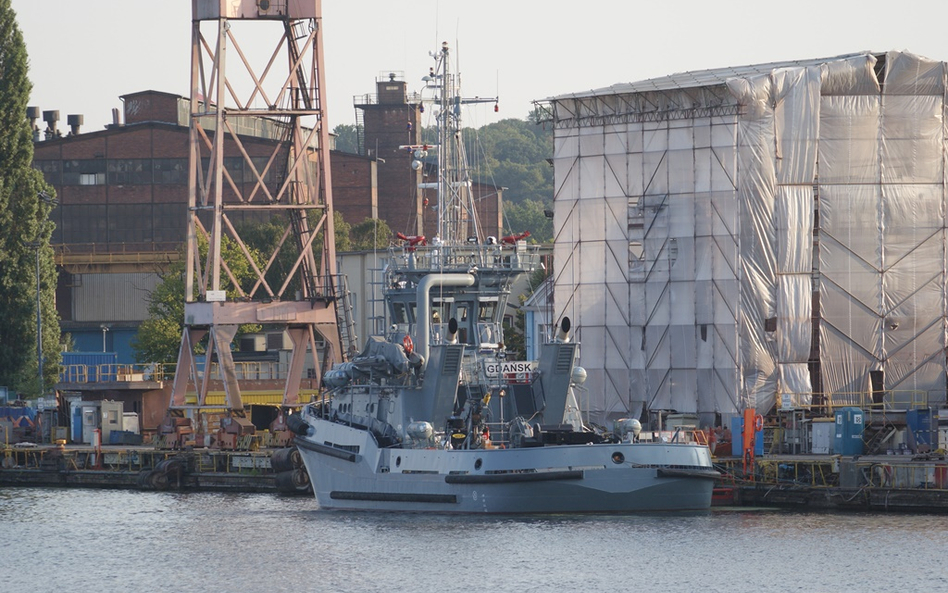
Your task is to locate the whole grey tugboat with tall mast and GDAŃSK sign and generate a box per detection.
[288,44,719,513]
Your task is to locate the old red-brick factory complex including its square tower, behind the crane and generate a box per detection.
[29,74,502,364]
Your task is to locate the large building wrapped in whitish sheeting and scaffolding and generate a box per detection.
[548,51,948,425]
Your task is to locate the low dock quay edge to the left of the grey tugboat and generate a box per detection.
[0,445,312,494]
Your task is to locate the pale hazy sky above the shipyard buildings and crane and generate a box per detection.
[13,0,948,132]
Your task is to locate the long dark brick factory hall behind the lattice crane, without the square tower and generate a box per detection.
[33,91,377,363]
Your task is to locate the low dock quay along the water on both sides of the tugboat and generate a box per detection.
[7,445,948,513]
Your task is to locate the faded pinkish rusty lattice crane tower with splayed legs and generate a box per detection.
[169,0,344,412]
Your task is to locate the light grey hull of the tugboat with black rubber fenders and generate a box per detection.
[296,419,717,514]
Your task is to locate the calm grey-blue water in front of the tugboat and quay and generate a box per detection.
[0,488,948,593]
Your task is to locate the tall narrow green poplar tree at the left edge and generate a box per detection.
[0,0,62,396]
